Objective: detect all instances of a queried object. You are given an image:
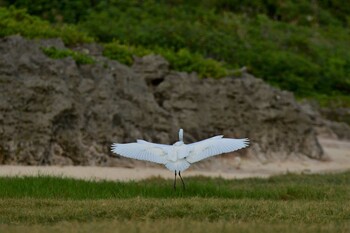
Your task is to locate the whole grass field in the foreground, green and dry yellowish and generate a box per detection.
[0,172,350,232]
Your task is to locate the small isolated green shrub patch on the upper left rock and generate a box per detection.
[41,47,95,65]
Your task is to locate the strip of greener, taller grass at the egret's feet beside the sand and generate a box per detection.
[0,172,350,201]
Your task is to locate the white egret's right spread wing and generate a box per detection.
[186,136,249,163]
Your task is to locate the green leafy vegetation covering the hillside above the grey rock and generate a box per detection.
[3,0,350,106]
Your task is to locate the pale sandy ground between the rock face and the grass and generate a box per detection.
[0,138,350,181]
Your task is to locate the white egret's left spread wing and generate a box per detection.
[112,140,169,164]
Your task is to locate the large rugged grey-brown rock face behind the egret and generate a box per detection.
[0,36,323,166]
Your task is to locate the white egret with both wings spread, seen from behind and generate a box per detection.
[111,129,249,189]
